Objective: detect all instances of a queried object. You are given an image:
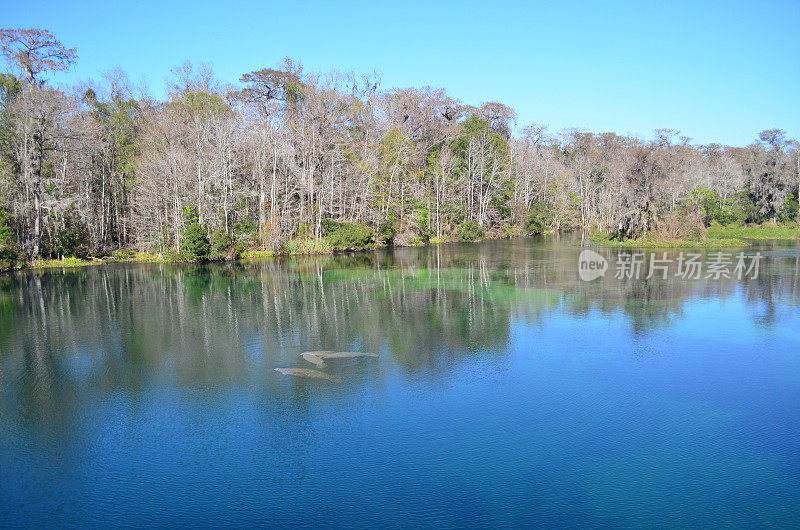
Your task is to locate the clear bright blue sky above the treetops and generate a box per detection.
[0,0,800,146]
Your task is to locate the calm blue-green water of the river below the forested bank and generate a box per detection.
[0,239,800,528]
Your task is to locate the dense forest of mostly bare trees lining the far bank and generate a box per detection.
[0,29,800,263]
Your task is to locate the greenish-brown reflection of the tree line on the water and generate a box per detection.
[0,239,800,398]
